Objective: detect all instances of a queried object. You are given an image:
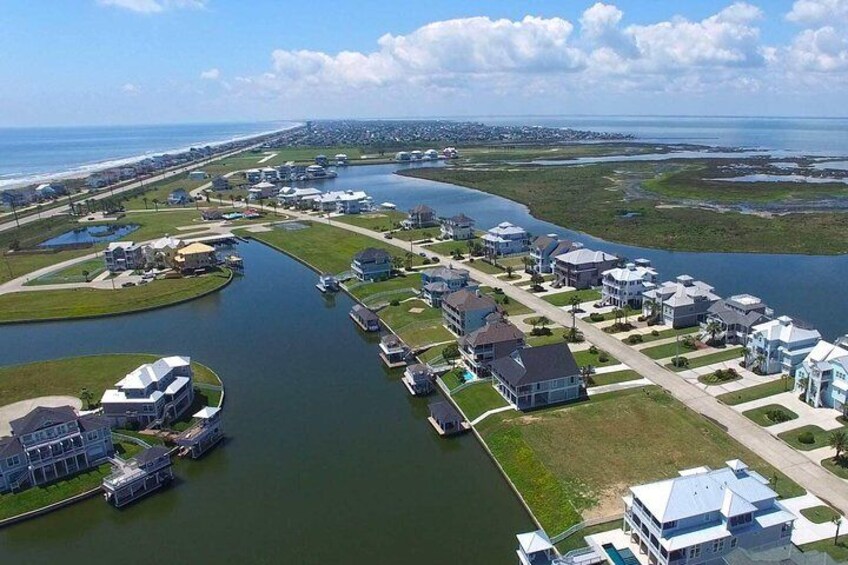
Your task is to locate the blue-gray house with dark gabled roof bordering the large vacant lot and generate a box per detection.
[489,343,586,410]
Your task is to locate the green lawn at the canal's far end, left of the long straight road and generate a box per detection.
[250,222,422,273]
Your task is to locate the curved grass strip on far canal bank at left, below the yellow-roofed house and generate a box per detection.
[0,270,231,323]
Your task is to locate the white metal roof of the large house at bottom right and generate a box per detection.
[630,462,777,522]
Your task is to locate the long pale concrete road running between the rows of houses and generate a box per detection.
[248,204,848,514]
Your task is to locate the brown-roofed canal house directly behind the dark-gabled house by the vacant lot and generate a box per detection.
[459,315,525,379]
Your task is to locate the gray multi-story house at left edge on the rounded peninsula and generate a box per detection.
[0,406,115,492]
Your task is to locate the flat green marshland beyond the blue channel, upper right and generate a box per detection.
[402,161,848,254]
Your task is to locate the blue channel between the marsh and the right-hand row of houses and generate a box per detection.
[330,159,848,339]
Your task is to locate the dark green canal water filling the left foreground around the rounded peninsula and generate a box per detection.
[0,242,532,565]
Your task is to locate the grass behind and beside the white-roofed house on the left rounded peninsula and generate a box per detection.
[0,353,221,407]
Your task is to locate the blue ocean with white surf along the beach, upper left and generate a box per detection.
[0,122,294,188]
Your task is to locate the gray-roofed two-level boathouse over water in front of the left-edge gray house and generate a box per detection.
[103,445,174,508]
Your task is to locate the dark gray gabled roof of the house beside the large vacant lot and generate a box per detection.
[491,343,580,387]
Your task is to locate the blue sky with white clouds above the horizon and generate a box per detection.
[0,0,848,126]
